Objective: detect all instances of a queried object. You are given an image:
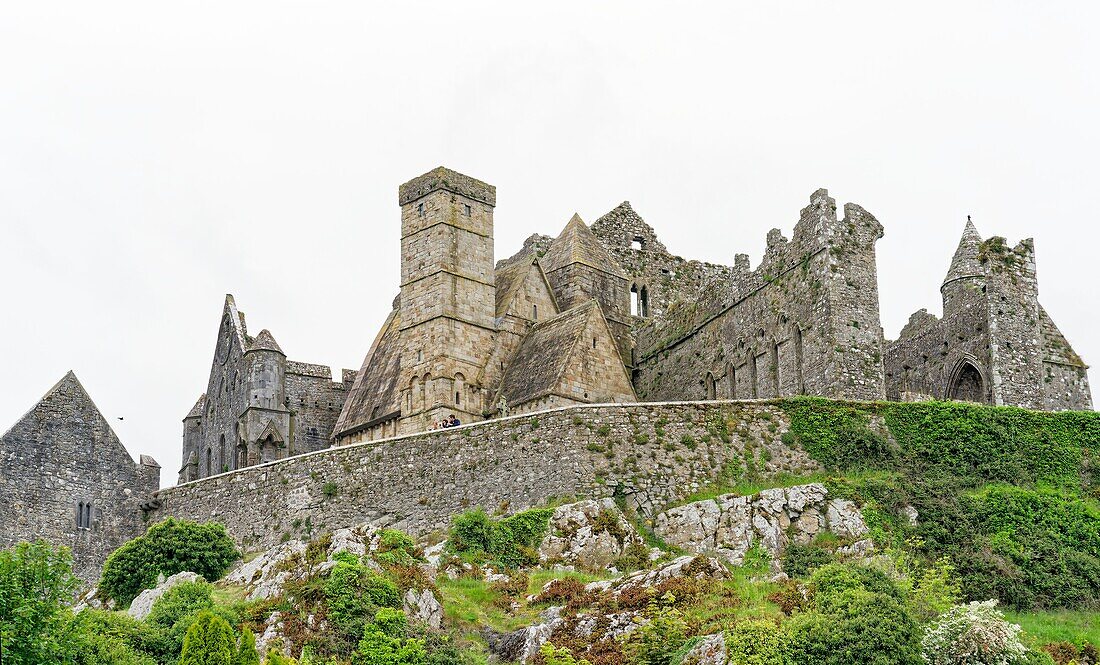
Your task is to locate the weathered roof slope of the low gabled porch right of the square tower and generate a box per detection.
[501,300,600,406]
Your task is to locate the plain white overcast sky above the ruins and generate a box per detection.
[0,0,1100,485]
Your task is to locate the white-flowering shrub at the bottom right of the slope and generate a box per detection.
[921,600,1027,665]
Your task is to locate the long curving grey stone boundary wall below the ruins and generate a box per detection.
[147,401,818,551]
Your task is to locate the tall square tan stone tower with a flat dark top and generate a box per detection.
[398,167,496,433]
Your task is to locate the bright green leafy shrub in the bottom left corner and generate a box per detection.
[0,541,78,665]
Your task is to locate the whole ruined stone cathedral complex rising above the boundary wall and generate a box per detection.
[179,167,1092,483]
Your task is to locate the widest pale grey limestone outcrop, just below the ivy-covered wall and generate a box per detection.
[653,483,873,565]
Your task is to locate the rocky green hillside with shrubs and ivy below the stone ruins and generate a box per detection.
[0,398,1100,665]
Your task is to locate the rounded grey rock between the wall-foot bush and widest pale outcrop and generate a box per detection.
[539,499,644,570]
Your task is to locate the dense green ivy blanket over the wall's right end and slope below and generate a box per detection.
[780,398,1100,608]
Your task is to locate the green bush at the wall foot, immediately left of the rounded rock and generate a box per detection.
[449,508,553,568]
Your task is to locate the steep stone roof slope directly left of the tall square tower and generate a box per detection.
[332,309,402,436]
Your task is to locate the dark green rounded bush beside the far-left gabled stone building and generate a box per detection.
[99,518,240,605]
